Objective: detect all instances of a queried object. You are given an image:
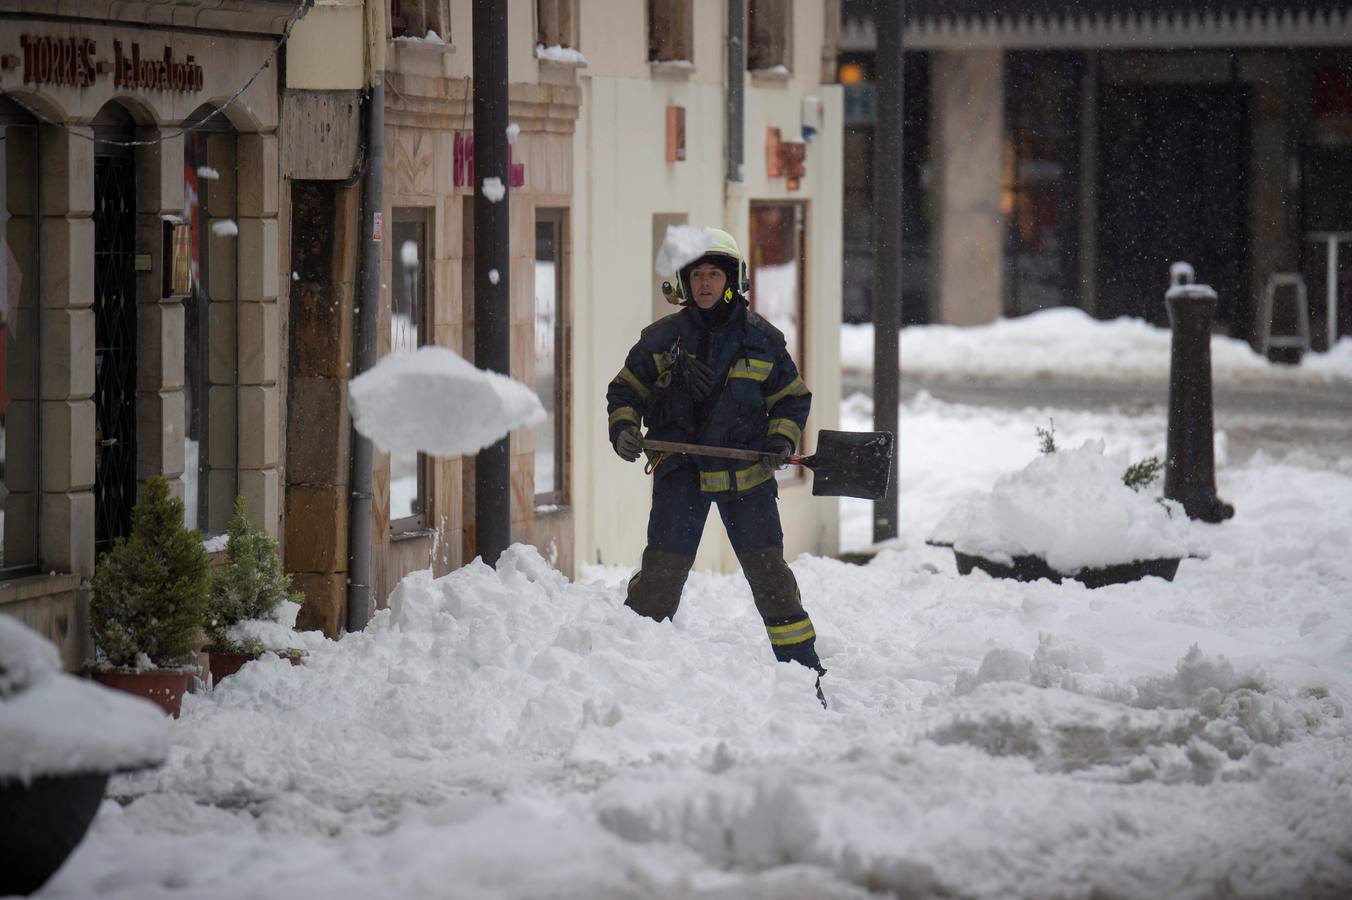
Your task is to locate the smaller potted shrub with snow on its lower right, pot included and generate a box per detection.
[207,497,304,682]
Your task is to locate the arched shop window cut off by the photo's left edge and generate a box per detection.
[0,97,42,567]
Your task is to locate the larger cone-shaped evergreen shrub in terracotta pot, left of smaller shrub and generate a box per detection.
[88,476,211,718]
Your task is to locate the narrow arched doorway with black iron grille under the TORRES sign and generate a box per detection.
[93,103,137,555]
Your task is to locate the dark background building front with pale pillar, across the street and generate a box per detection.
[841,0,1352,349]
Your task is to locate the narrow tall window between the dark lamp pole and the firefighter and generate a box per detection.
[534,209,565,507]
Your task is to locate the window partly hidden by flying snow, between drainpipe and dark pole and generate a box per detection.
[389,208,431,532]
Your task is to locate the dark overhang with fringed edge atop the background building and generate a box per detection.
[840,0,1352,53]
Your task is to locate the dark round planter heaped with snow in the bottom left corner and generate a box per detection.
[0,615,169,896]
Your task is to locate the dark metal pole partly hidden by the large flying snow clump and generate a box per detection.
[473,0,511,565]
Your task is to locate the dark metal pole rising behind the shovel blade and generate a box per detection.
[873,0,904,543]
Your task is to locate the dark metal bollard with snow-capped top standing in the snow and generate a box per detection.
[1164,262,1234,522]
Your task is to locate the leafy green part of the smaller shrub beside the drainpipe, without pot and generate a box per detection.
[207,497,304,653]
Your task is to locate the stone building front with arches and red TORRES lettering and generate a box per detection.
[0,0,304,666]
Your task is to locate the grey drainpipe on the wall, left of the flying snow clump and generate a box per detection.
[347,72,385,631]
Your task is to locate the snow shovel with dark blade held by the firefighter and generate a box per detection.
[644,431,894,500]
